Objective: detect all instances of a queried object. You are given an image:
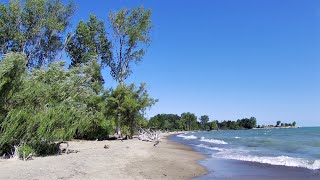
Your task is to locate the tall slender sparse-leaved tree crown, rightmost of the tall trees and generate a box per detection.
[107,7,151,84]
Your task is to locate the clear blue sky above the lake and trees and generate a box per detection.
[66,0,320,126]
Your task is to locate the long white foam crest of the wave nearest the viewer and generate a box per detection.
[212,151,320,170]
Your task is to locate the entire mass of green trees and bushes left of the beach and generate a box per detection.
[0,0,157,157]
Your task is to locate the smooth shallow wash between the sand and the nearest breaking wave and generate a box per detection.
[171,131,320,180]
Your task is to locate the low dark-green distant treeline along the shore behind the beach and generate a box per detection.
[148,112,257,131]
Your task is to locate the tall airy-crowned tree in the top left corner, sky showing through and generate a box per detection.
[0,0,75,68]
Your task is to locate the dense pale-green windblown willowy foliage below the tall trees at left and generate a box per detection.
[0,53,112,154]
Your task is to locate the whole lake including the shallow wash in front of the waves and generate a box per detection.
[172,127,320,179]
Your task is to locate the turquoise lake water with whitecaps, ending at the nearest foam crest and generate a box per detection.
[176,127,320,170]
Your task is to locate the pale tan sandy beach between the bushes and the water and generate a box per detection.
[0,134,207,179]
